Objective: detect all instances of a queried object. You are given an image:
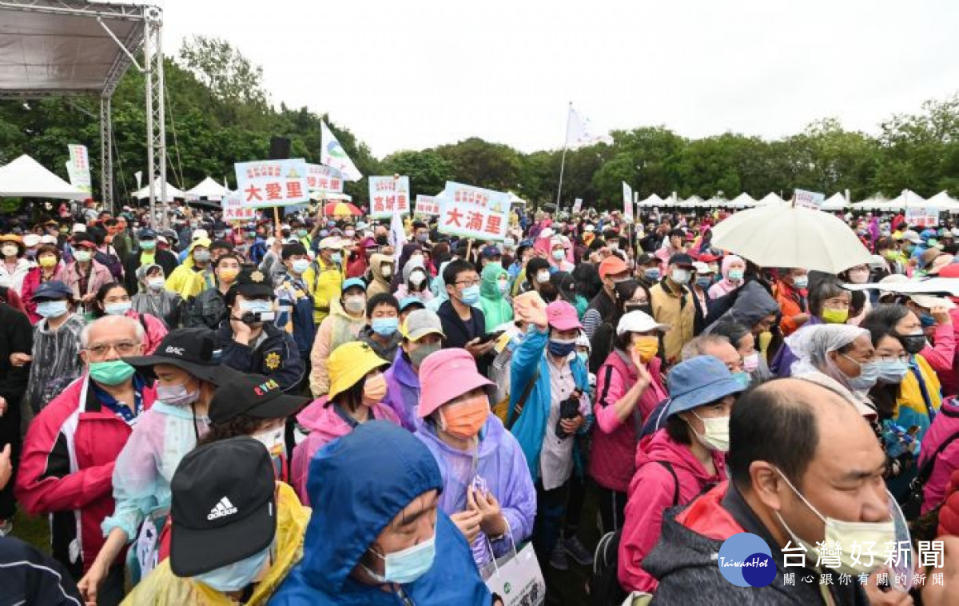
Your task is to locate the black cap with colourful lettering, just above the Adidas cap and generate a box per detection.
[210,374,310,424]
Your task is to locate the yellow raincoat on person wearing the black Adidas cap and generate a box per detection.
[121,482,310,606]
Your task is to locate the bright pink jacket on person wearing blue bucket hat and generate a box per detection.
[618,429,726,593]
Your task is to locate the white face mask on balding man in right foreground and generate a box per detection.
[776,469,896,575]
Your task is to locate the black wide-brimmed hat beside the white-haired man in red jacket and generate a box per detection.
[123,328,242,385]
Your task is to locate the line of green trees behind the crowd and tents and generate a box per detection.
[0,36,959,209]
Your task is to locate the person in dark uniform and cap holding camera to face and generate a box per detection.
[216,269,305,391]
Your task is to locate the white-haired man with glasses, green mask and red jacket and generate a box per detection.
[14,316,156,604]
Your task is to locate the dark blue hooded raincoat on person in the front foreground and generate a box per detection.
[269,421,492,606]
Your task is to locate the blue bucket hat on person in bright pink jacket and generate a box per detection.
[666,356,745,417]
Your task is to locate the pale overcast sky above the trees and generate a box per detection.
[159,0,959,157]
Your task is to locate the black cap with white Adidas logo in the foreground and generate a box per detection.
[170,436,276,577]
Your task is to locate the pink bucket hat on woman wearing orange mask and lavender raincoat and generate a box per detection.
[416,350,496,418]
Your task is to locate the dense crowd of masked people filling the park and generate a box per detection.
[0,201,959,606]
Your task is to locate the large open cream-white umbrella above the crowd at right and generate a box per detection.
[712,205,872,274]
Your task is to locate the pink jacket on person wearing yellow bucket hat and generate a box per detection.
[290,396,400,505]
